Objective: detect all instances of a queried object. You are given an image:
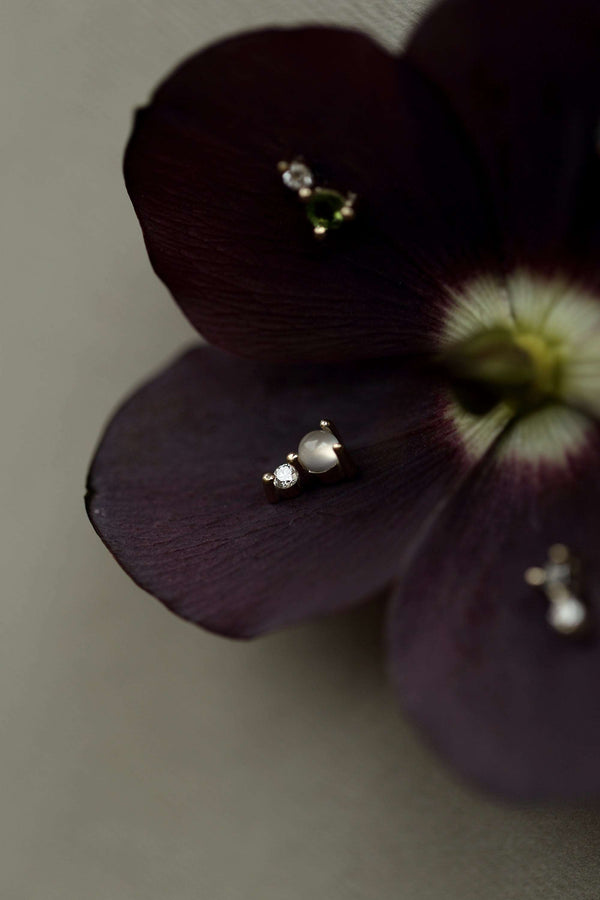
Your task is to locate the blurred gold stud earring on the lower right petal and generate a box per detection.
[525,544,589,636]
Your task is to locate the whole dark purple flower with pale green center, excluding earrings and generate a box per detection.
[88,0,600,798]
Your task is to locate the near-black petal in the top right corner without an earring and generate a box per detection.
[407,0,600,282]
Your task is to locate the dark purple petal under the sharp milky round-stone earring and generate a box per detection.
[87,348,494,637]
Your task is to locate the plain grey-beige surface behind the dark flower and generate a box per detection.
[0,0,600,900]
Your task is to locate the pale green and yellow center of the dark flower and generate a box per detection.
[439,271,600,465]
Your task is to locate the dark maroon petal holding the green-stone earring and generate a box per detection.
[125,28,497,361]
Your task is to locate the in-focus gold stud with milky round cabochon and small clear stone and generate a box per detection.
[262,419,358,503]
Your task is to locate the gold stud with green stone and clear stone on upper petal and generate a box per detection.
[277,158,356,239]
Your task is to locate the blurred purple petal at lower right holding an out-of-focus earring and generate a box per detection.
[390,414,600,799]
